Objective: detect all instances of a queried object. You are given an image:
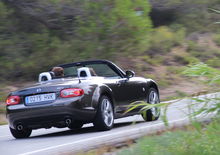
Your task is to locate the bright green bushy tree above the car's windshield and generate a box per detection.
[72,0,151,58]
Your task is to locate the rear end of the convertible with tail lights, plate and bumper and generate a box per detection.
[6,81,95,136]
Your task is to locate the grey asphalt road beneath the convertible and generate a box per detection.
[0,94,216,155]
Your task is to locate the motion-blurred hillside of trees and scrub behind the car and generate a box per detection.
[0,0,220,115]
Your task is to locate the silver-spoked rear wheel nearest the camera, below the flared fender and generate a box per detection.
[93,96,114,131]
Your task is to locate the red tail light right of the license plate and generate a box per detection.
[60,88,84,98]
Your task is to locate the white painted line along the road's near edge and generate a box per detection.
[19,117,188,155]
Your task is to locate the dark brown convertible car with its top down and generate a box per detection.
[6,60,160,138]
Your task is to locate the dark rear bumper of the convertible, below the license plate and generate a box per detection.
[7,100,96,129]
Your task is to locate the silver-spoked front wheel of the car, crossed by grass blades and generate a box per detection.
[141,88,160,121]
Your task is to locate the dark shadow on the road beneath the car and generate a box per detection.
[30,121,144,139]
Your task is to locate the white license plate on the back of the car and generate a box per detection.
[25,93,56,104]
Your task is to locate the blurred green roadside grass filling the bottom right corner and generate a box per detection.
[117,119,220,155]
